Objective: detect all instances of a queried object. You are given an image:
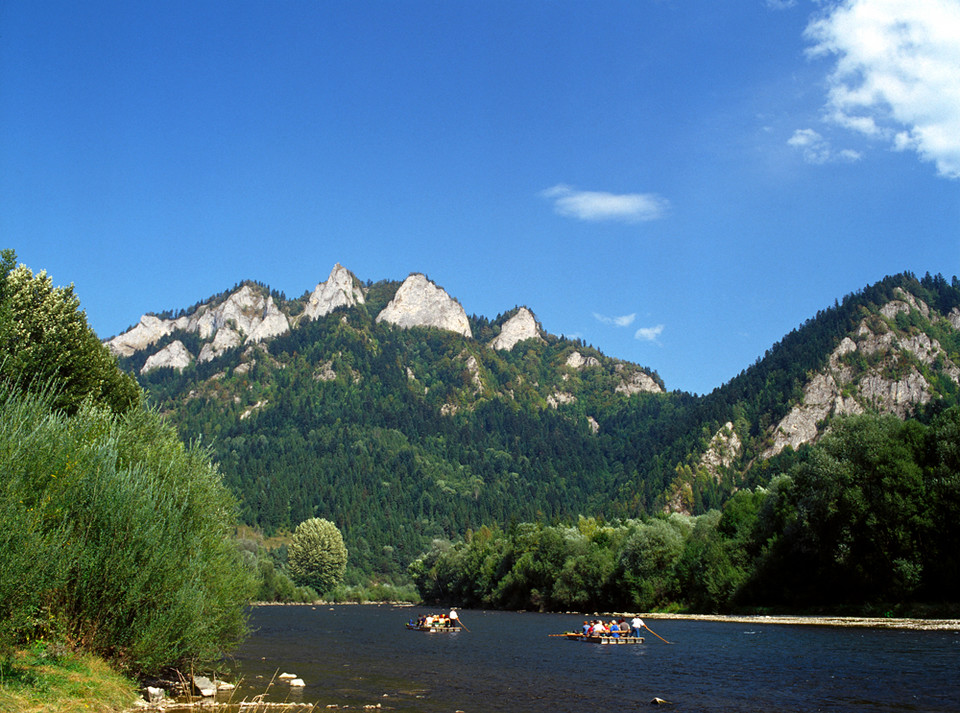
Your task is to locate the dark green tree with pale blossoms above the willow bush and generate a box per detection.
[0,250,141,413]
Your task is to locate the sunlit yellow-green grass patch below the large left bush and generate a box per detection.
[0,642,137,713]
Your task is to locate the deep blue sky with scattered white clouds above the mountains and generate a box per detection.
[0,0,960,393]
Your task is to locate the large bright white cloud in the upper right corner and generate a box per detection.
[805,0,960,178]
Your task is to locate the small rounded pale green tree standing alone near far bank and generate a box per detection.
[288,517,347,593]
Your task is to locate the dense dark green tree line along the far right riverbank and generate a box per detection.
[410,407,960,613]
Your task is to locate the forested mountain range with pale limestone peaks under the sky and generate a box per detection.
[112,265,960,574]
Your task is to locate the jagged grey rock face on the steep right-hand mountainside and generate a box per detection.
[761,288,960,458]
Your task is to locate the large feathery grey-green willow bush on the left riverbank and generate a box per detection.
[0,391,252,673]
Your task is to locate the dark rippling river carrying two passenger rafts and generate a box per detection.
[212,605,960,713]
